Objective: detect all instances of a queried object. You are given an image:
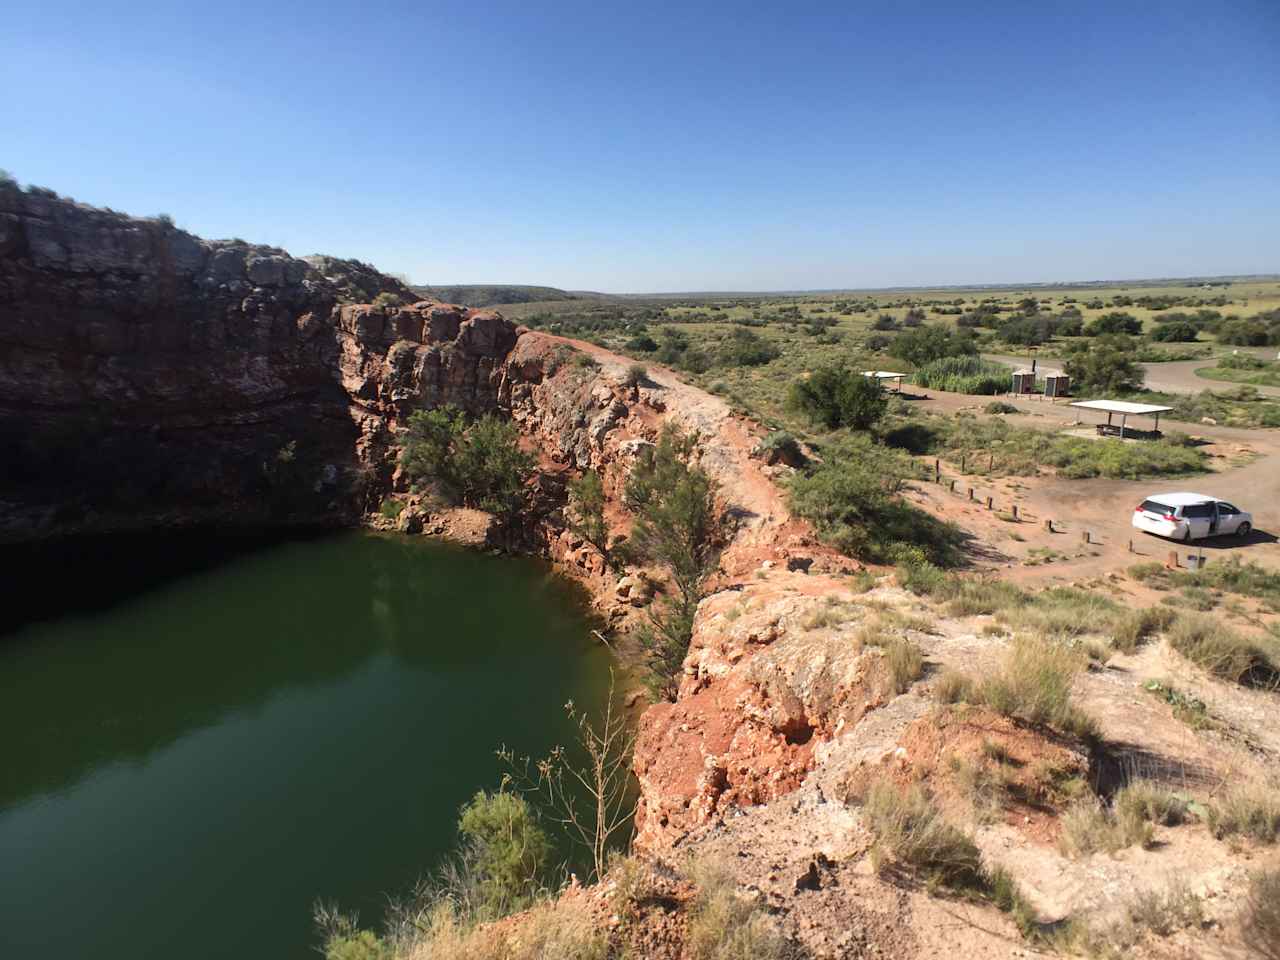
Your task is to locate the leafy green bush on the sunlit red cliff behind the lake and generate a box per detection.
[401,407,534,518]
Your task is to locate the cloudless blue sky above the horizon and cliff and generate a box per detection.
[0,0,1280,292]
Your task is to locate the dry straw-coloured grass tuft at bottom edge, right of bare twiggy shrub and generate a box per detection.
[686,860,792,960]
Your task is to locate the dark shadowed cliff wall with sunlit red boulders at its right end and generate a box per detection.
[0,187,516,539]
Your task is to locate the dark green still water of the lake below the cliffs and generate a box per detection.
[0,532,612,960]
